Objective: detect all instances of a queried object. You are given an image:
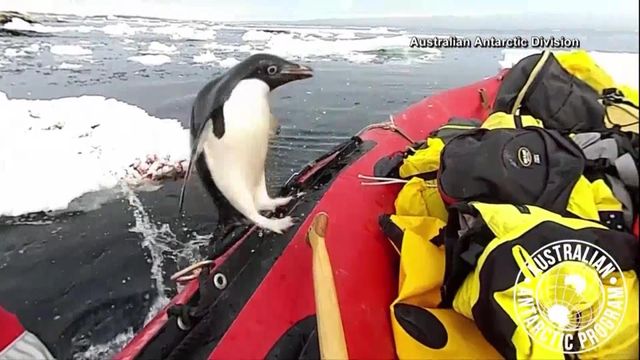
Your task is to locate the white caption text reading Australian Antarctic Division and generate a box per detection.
[409,36,580,49]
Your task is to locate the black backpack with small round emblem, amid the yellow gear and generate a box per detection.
[437,116,585,214]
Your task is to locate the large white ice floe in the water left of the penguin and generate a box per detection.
[0,92,189,216]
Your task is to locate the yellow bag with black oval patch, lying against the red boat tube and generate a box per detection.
[380,215,500,359]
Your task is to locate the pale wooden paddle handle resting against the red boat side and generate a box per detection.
[307,212,349,360]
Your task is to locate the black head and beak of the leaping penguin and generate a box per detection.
[242,54,313,90]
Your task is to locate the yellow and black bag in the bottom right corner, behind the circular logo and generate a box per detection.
[441,202,639,359]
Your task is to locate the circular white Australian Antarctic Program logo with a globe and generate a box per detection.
[513,240,627,354]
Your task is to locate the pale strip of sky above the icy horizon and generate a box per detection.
[5,0,638,20]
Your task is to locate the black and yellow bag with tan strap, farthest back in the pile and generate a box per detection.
[493,50,639,134]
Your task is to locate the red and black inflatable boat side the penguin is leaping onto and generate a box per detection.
[115,73,504,360]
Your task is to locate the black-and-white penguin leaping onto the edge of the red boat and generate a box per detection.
[178,53,313,236]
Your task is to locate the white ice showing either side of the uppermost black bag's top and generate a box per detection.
[499,49,640,88]
